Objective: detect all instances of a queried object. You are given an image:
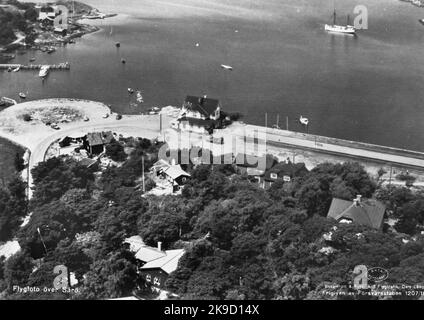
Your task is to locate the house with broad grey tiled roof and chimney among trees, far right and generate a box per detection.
[327,195,386,229]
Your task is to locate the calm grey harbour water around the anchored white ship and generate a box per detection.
[0,0,424,180]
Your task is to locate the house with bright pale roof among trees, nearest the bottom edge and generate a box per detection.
[124,236,185,289]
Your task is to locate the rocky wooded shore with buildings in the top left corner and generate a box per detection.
[0,0,115,55]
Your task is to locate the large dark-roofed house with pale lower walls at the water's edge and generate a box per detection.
[172,96,223,134]
